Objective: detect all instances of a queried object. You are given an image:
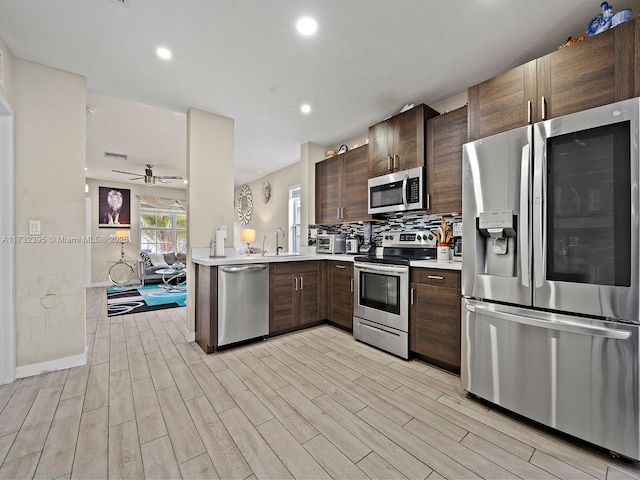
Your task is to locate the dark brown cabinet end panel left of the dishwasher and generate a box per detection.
[195,264,218,353]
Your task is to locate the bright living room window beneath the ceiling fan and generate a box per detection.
[140,202,187,253]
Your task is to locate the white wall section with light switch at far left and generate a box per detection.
[13,59,86,368]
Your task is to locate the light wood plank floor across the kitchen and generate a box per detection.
[0,289,640,479]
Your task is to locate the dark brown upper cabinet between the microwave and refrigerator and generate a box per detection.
[427,106,467,215]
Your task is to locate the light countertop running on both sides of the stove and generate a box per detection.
[191,248,462,271]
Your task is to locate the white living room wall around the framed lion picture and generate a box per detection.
[86,179,188,286]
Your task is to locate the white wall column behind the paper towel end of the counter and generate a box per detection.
[187,108,235,337]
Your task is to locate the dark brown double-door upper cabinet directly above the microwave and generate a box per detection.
[369,104,438,178]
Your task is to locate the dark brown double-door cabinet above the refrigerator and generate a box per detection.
[468,18,640,141]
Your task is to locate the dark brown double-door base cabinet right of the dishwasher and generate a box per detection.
[269,261,323,335]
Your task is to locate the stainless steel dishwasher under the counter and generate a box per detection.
[218,263,269,347]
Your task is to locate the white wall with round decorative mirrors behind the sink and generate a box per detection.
[233,162,300,253]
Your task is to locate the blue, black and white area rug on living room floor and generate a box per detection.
[107,285,187,317]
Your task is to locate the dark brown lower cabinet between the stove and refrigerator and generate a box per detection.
[409,268,461,373]
